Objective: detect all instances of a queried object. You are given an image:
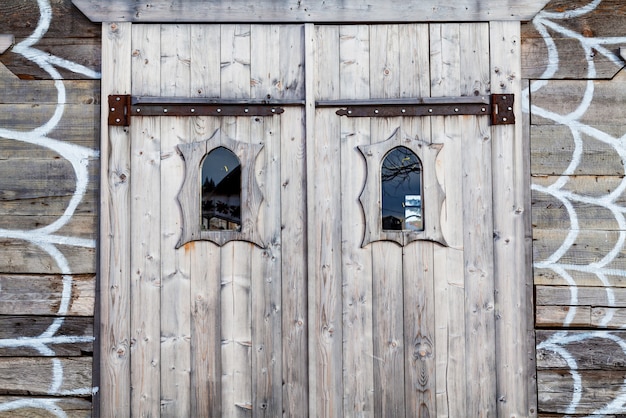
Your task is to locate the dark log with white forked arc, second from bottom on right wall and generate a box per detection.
[536,330,626,371]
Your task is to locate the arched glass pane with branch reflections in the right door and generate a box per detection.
[381,147,424,231]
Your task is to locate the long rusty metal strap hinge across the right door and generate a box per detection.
[330,94,515,125]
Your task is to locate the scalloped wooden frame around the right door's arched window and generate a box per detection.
[358,128,447,247]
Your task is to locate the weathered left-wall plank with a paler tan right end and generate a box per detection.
[0,272,96,316]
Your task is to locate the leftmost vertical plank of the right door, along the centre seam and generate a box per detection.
[307,22,343,417]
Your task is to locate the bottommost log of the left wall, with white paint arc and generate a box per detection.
[0,396,92,418]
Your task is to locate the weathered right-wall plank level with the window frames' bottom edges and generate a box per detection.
[533,228,626,276]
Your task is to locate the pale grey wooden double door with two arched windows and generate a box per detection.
[99,22,534,417]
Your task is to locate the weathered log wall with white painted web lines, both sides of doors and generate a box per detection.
[0,0,626,417]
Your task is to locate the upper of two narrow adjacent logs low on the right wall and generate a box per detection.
[535,286,626,307]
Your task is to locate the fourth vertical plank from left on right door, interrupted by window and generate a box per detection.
[399,25,437,417]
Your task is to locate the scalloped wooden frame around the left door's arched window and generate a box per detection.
[176,129,264,248]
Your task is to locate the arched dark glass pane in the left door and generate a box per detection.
[201,147,241,231]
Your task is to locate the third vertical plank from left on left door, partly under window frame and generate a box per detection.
[161,25,193,416]
